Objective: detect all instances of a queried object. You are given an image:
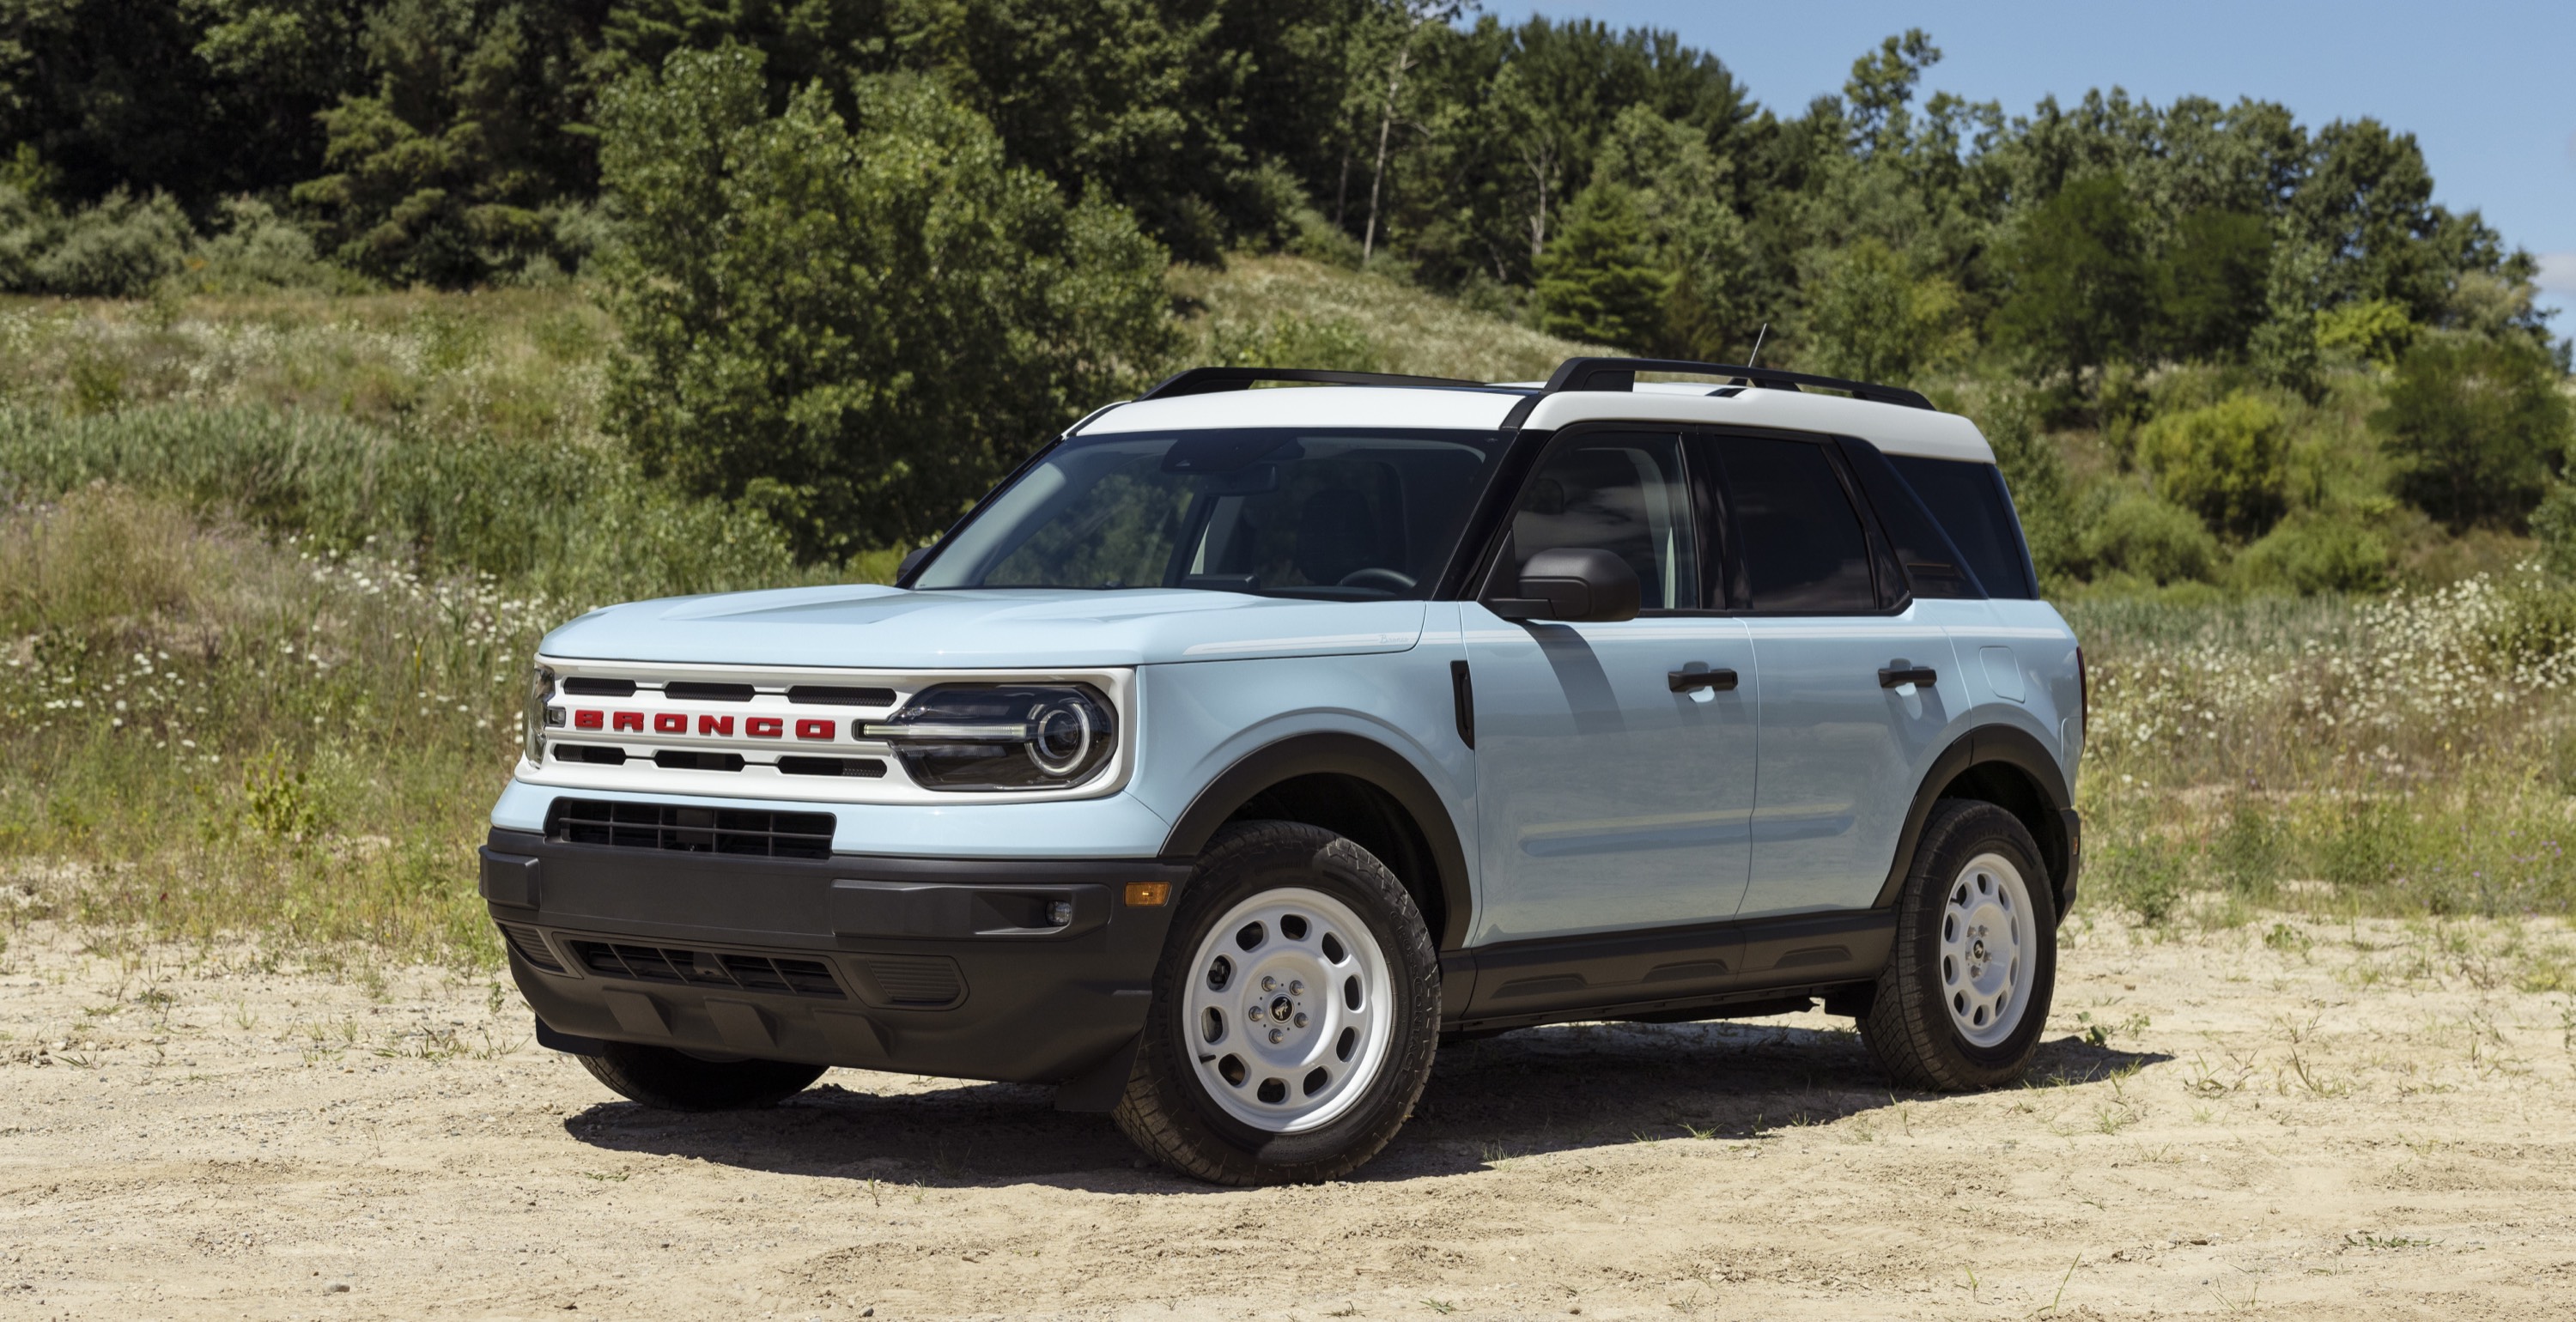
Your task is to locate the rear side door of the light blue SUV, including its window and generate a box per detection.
[1708,433,1960,918]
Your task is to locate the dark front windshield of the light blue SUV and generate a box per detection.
[912,428,1494,600]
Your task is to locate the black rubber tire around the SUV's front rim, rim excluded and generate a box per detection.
[1115,822,1440,1186]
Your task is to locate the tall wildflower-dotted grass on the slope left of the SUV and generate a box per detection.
[0,294,837,964]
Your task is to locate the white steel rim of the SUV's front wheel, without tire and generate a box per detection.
[1180,887,1394,1134]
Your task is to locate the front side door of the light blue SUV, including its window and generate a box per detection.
[1463,430,1757,946]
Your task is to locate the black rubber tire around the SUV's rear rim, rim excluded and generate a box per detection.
[1860,799,2058,1093]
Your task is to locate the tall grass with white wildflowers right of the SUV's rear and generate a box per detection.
[2069,567,2576,923]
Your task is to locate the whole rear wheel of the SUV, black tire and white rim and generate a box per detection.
[1860,799,2058,1090]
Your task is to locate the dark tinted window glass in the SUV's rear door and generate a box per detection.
[1716,435,1878,616]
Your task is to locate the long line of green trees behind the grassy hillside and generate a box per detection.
[0,0,2576,582]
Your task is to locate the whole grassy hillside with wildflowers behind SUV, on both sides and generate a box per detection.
[0,258,2576,977]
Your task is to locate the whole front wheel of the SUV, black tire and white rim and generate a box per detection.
[1115,822,1440,1186]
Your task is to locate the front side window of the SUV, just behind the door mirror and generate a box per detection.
[1512,433,1700,610]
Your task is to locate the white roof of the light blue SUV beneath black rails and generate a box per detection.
[1082,381,1994,464]
